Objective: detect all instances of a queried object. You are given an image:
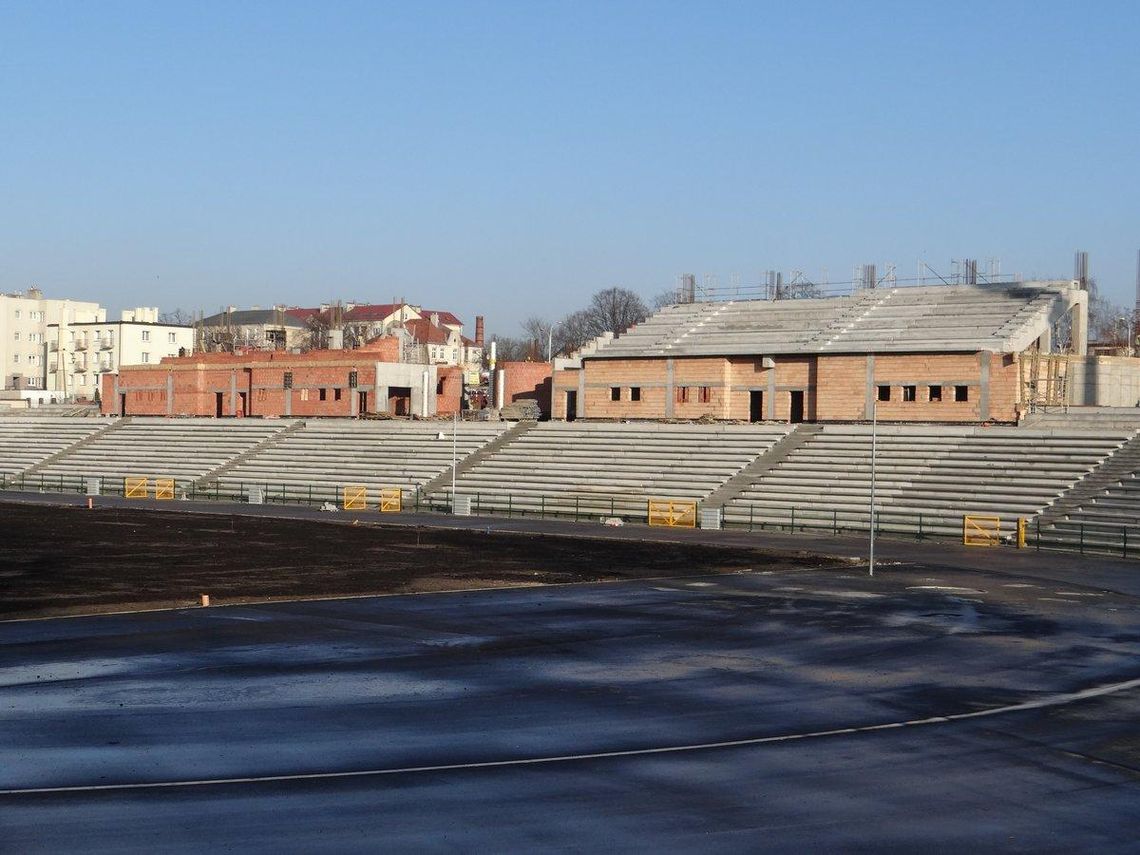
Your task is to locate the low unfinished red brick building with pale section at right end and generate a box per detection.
[101,337,463,418]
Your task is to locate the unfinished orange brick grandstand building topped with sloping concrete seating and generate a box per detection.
[553,282,1088,423]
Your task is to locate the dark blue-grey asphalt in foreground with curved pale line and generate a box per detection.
[0,564,1140,853]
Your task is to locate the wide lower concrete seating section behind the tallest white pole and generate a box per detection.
[724,425,1129,534]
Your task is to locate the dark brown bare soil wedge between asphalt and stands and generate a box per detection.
[0,504,819,619]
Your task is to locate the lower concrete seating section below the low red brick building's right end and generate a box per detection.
[212,421,510,503]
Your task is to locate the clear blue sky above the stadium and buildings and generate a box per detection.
[0,0,1140,334]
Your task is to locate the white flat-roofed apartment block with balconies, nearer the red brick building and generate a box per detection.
[47,307,194,400]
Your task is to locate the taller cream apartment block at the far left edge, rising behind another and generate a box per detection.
[0,288,107,397]
